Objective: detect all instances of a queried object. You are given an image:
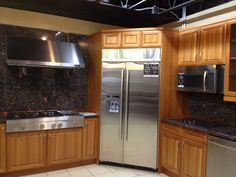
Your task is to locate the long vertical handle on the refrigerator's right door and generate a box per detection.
[125,70,130,141]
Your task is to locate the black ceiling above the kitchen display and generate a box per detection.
[0,0,230,27]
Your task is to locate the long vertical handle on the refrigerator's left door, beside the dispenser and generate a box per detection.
[120,69,124,140]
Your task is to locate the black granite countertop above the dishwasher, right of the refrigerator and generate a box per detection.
[162,119,236,141]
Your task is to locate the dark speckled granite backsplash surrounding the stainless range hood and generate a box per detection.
[0,25,88,112]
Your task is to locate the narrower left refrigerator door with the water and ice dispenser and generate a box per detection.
[100,62,125,163]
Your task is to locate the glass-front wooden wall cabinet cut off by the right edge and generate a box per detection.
[224,20,236,102]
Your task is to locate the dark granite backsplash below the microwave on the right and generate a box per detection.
[187,93,236,123]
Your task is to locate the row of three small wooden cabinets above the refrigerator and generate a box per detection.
[102,30,162,48]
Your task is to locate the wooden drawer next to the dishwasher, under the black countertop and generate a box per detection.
[182,129,207,143]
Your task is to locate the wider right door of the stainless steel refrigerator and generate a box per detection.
[124,63,159,169]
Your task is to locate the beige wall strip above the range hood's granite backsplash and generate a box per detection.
[0,7,117,35]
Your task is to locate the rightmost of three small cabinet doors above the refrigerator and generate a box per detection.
[142,31,161,47]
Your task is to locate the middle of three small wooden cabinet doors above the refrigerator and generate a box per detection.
[122,31,141,48]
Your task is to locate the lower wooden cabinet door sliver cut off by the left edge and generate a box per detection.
[0,124,6,173]
